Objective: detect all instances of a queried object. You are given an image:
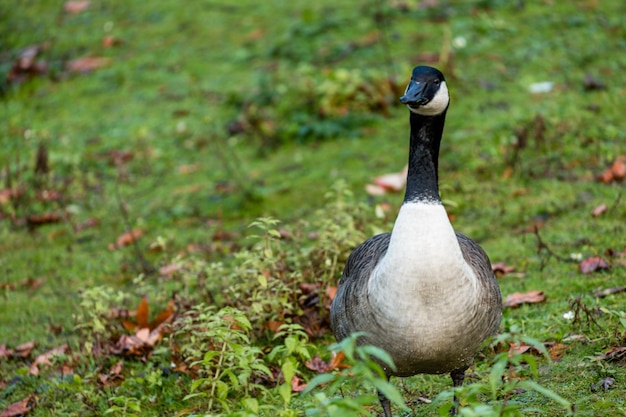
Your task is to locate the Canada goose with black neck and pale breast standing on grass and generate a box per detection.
[331,66,502,417]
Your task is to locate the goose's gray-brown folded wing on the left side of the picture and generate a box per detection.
[330,233,391,341]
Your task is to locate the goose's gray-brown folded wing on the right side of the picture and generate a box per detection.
[456,232,502,337]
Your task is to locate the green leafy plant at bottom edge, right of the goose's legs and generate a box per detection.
[435,328,574,417]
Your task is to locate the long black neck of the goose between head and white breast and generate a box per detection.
[404,111,446,203]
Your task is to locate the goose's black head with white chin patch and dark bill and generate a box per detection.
[400,66,450,116]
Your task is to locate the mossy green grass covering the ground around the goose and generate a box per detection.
[0,0,626,415]
